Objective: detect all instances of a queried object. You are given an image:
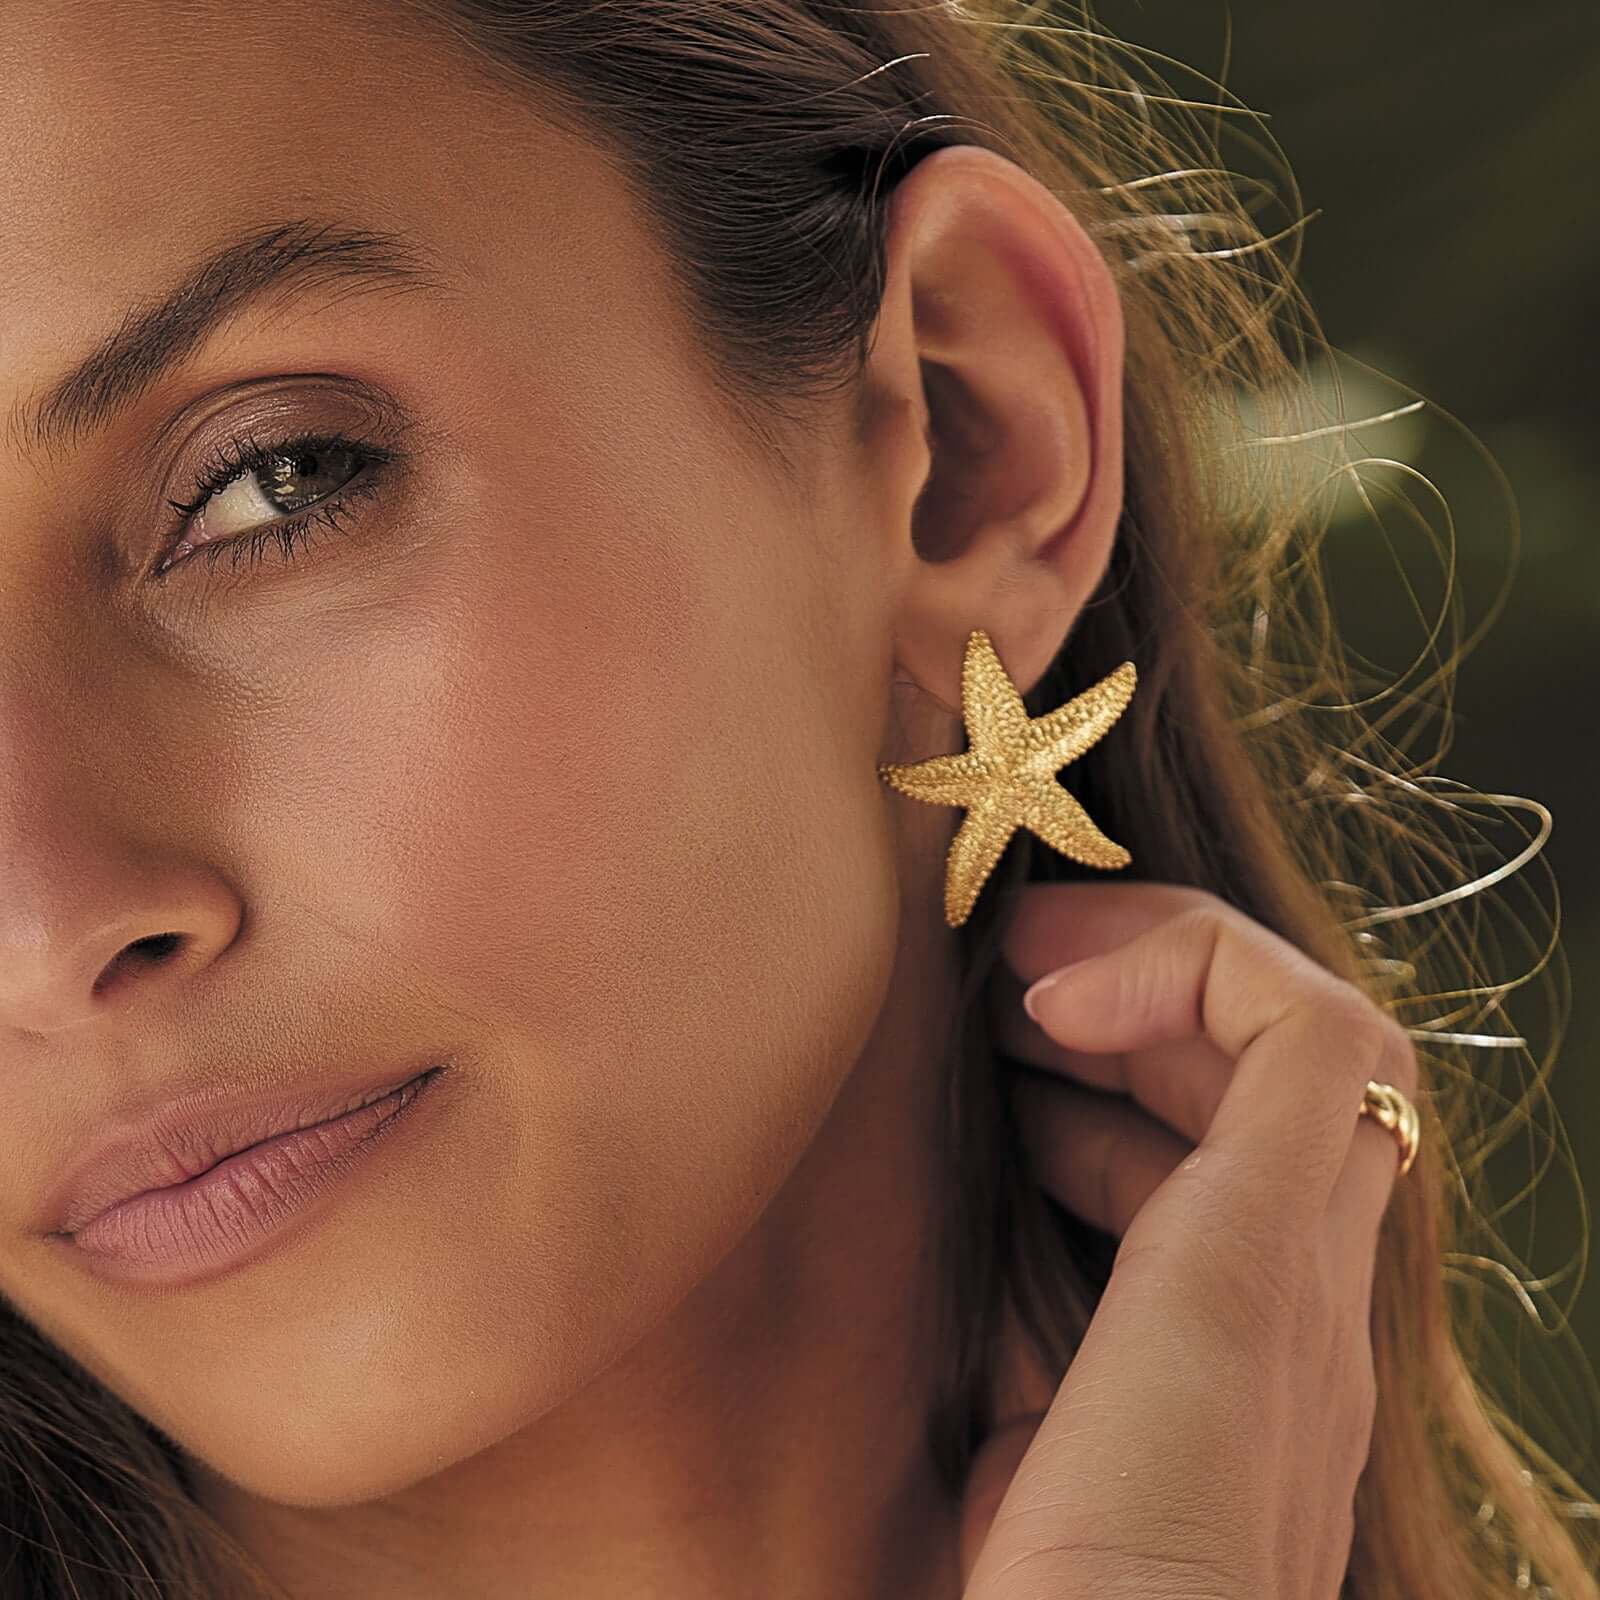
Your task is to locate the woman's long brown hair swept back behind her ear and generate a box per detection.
[0,0,1600,1600]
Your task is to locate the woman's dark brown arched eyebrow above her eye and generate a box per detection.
[8,218,454,456]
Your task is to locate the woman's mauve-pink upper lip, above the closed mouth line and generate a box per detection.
[43,1054,445,1234]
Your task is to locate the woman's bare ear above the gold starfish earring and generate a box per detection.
[864,146,1123,715]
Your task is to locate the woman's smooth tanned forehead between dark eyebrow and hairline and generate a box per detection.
[0,0,622,388]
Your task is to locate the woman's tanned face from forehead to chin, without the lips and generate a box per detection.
[0,0,934,1506]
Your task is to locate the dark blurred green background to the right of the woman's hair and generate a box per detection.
[1096,0,1600,1490]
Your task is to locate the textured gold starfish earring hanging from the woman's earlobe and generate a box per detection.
[878,627,1136,928]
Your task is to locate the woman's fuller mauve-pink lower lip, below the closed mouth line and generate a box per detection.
[61,1067,443,1288]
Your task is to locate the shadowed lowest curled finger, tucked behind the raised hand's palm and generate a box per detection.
[1011,1072,1194,1238]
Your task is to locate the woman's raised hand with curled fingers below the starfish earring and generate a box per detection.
[962,883,1418,1600]
